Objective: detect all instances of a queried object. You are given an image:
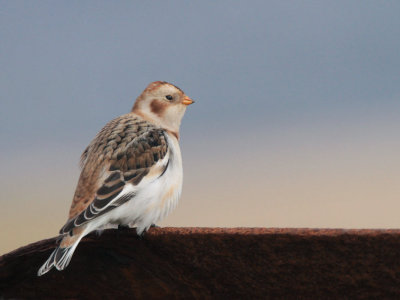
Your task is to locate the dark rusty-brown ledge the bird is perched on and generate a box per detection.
[0,228,400,299]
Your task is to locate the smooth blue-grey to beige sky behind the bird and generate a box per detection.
[0,1,400,254]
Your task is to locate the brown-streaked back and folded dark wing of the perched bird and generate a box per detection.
[60,114,169,234]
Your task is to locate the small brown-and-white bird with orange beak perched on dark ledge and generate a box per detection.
[38,81,194,276]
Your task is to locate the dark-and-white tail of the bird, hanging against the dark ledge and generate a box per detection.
[37,234,84,276]
